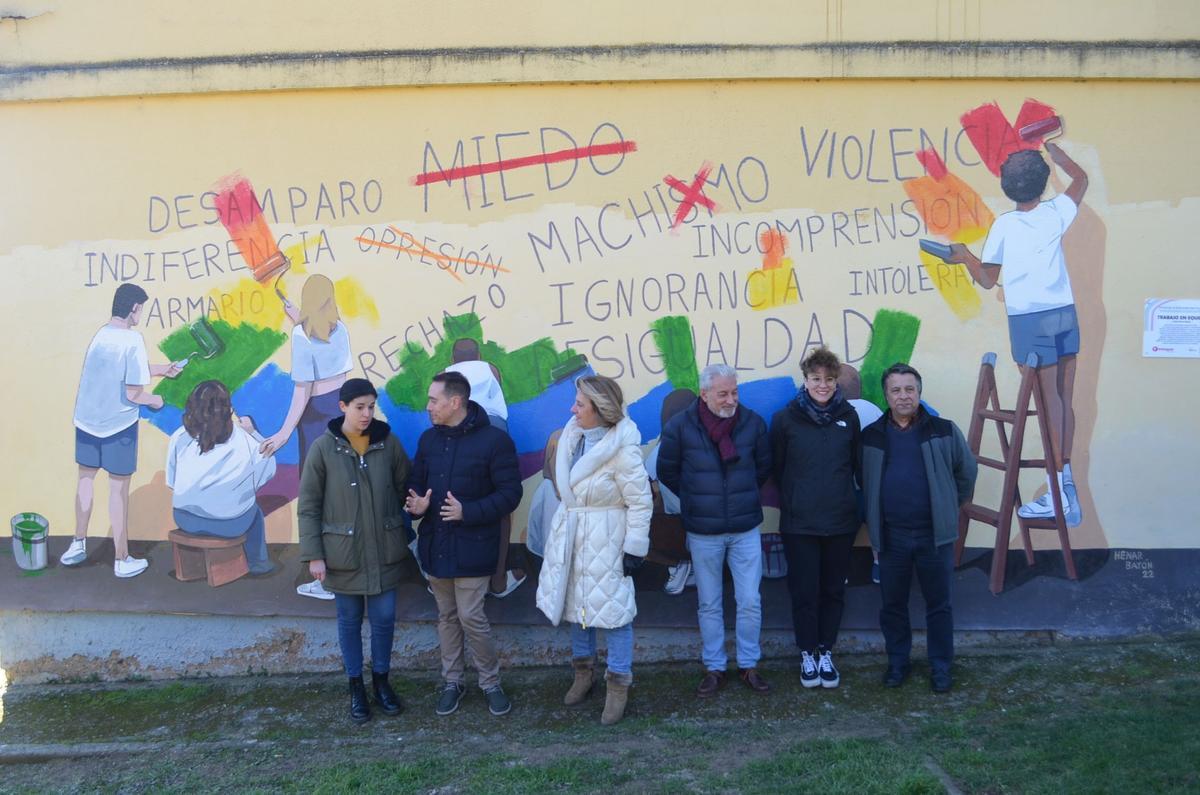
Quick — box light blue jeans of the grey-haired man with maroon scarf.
[688,527,762,671]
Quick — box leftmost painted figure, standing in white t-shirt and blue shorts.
[59,282,181,578]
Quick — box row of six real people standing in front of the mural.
[299,348,976,724]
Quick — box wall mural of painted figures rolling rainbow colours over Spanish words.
[5,89,1190,624]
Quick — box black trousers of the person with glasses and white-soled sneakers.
[784,533,856,654]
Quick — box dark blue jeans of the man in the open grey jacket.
[880,527,954,671]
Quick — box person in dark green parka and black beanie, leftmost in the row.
[298,378,409,723]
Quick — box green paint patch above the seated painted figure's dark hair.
[154,321,288,408]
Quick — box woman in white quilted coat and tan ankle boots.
[538,376,653,725]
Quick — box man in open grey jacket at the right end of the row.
[863,363,977,693]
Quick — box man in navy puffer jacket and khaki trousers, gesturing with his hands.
[404,372,521,715]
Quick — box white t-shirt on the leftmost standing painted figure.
[74,325,150,438]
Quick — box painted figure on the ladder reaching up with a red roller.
[946,116,1087,527]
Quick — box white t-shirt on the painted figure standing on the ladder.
[980,193,1079,315]
